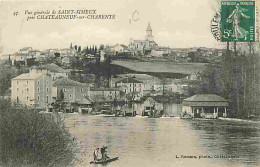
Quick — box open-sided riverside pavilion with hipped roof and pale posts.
[181,94,229,118]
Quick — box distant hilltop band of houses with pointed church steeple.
[1,23,224,66]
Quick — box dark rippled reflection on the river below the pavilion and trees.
[187,120,260,166]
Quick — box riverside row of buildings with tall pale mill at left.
[7,63,196,113]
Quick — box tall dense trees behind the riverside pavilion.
[189,43,260,117]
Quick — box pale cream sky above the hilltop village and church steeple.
[0,0,235,54]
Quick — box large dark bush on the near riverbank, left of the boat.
[0,100,77,167]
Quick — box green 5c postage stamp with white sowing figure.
[221,1,255,42]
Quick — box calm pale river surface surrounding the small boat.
[65,114,260,167]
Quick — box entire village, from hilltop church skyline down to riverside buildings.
[1,23,250,117]
